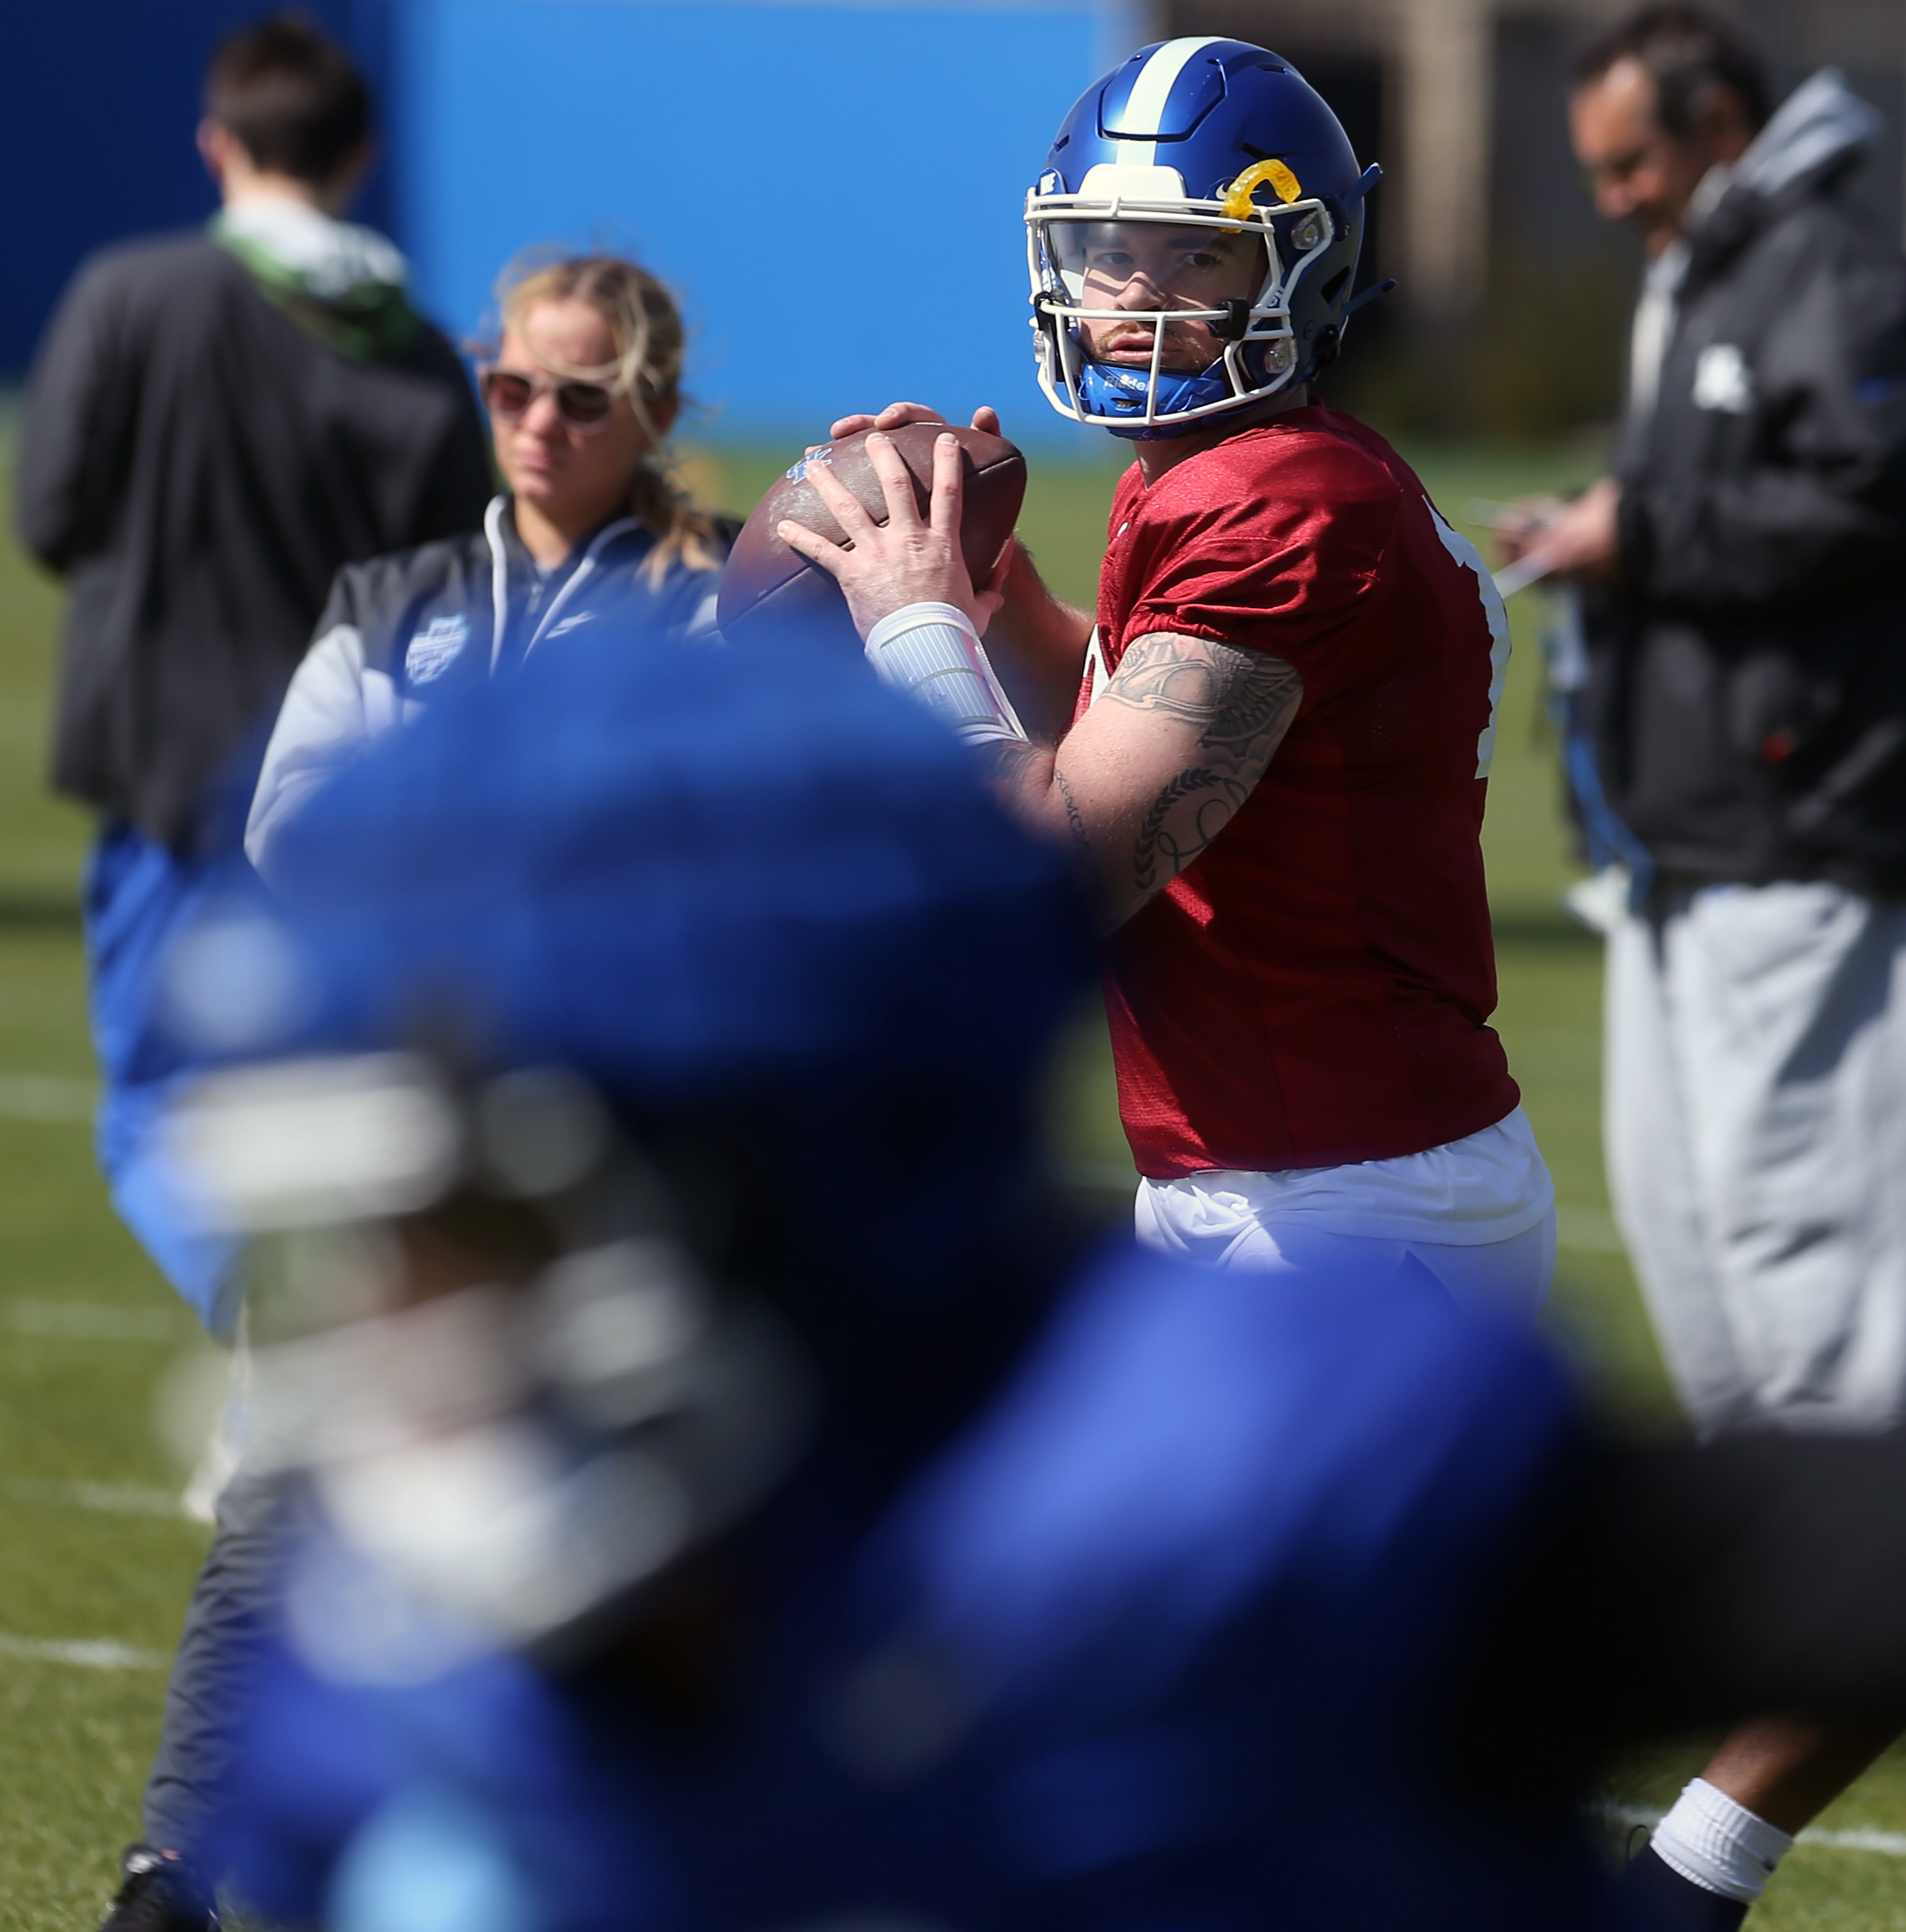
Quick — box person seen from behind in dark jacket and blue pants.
[17,15,489,1325]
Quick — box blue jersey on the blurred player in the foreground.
[208,1250,1605,1932]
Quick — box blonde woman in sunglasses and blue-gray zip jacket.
[245,255,735,877]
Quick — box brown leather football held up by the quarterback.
[715,423,1026,643]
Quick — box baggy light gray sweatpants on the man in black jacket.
[1603,885,1906,1434]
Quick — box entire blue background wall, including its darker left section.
[0,0,1144,440]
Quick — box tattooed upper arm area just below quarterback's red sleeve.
[1104,636,1303,893]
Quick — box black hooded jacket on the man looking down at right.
[1585,73,1906,895]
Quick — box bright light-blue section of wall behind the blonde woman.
[390,0,1129,439]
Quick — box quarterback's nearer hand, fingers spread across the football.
[775,437,1013,638]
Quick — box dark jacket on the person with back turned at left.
[15,236,491,846]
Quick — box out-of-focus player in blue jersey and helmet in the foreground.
[145,622,1906,1932]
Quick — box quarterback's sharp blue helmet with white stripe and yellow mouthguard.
[1026,39,1380,439]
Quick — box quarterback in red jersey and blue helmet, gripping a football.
[781,39,1554,1314]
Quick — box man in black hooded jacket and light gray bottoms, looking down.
[1508,6,1906,1926]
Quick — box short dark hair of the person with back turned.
[205,14,371,184]
